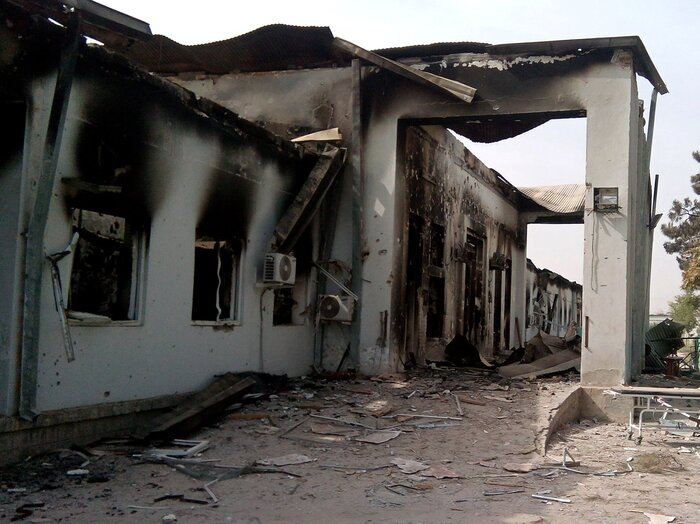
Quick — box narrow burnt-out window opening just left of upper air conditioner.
[192,236,242,322]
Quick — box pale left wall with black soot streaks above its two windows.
[10,50,315,411]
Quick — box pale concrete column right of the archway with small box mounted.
[581,53,644,386]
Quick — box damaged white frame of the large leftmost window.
[67,207,148,326]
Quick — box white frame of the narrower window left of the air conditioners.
[190,234,245,326]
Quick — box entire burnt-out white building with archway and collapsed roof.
[0,0,666,457]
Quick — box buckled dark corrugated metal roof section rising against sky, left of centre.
[119,24,348,74]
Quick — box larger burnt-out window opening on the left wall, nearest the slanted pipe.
[68,209,144,320]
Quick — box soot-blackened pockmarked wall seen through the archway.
[398,126,525,361]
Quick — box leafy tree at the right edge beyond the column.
[661,151,700,291]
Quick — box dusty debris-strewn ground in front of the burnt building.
[0,369,700,523]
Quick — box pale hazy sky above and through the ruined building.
[101,0,700,313]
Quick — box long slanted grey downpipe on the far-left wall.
[19,13,82,420]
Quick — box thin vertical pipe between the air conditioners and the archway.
[350,59,364,367]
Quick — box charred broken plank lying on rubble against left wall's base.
[134,373,255,439]
